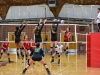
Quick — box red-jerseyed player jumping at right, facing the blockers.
[62,27,71,57]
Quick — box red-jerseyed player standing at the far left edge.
[0,38,11,63]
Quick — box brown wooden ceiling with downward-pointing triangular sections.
[0,0,100,19]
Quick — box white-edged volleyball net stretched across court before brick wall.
[0,24,91,48]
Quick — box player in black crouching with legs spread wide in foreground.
[22,43,51,75]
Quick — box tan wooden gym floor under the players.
[0,54,100,75]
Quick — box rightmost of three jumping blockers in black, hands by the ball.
[50,19,59,62]
